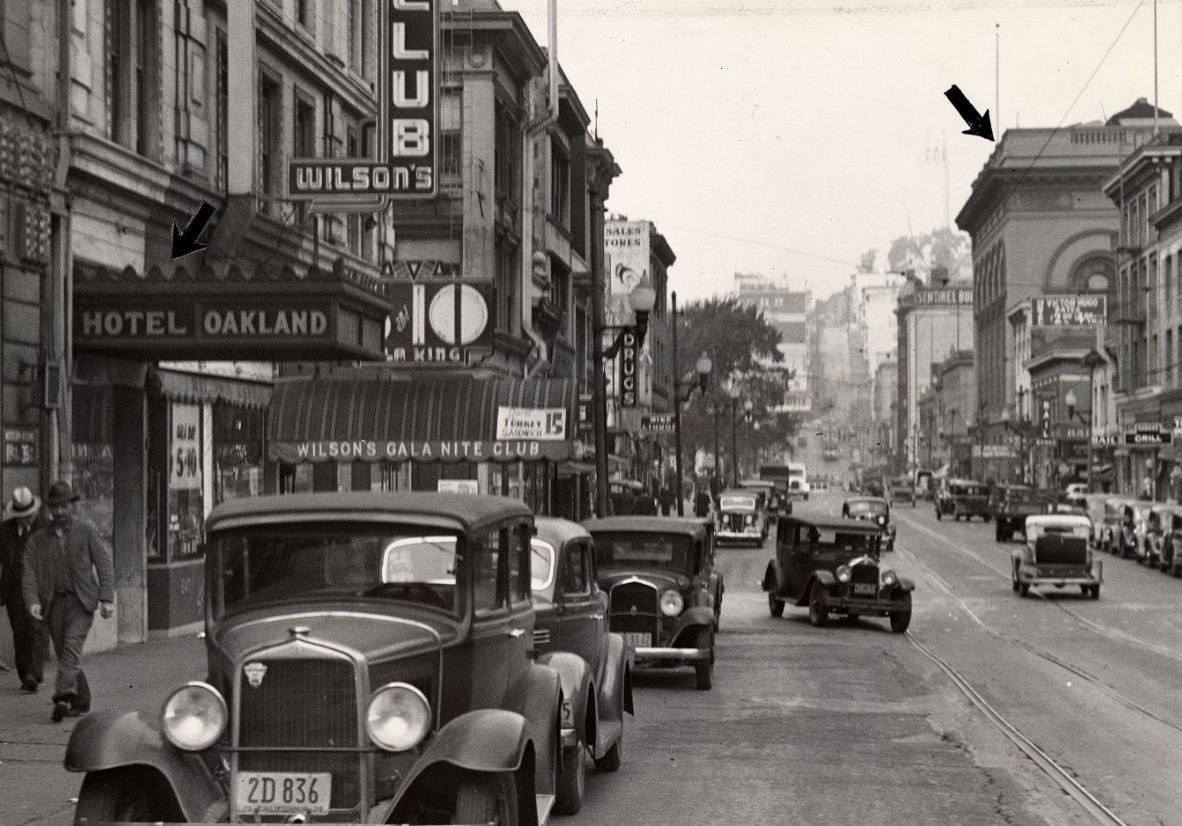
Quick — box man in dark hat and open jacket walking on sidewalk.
[22,481,115,723]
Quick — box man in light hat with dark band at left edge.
[0,488,50,694]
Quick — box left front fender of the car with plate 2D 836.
[65,710,227,822]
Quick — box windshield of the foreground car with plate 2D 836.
[206,523,462,617]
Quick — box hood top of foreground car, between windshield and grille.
[210,607,460,662]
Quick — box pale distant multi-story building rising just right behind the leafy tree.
[734,273,812,416]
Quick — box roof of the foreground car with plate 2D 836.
[206,490,533,531]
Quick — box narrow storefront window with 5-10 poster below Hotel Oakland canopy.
[168,403,204,560]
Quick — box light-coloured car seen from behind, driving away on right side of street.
[1011,514,1104,599]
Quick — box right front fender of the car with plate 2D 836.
[391,709,541,826]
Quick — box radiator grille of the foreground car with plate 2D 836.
[236,658,365,809]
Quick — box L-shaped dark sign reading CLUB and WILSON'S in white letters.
[287,0,442,213]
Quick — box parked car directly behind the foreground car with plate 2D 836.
[530,516,632,814]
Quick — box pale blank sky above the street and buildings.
[501,0,1182,301]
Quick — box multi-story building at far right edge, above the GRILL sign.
[1093,130,1182,500]
